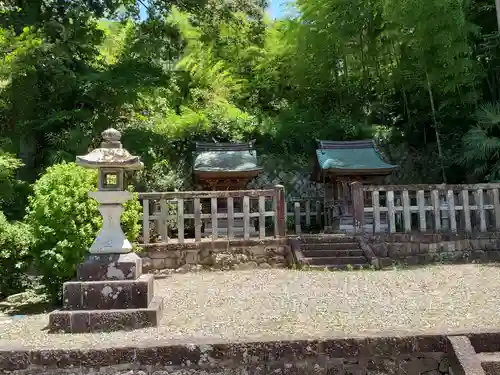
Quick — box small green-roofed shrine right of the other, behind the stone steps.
[313,140,398,231]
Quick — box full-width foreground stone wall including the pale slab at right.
[4,332,500,375]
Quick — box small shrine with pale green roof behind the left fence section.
[193,141,262,237]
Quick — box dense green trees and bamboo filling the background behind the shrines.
[0,0,500,210]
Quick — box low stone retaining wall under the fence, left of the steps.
[140,238,290,272]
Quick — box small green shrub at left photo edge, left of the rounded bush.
[0,212,33,299]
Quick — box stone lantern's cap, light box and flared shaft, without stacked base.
[76,128,143,254]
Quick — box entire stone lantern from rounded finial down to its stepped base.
[49,129,163,333]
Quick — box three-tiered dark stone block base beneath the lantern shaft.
[49,253,163,333]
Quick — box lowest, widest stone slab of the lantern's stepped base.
[48,297,163,333]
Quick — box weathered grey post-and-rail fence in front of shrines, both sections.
[139,183,500,239]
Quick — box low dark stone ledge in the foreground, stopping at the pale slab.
[0,335,449,374]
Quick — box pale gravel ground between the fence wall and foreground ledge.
[0,265,500,348]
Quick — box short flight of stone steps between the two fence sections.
[291,234,371,270]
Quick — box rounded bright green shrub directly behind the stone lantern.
[26,163,141,301]
